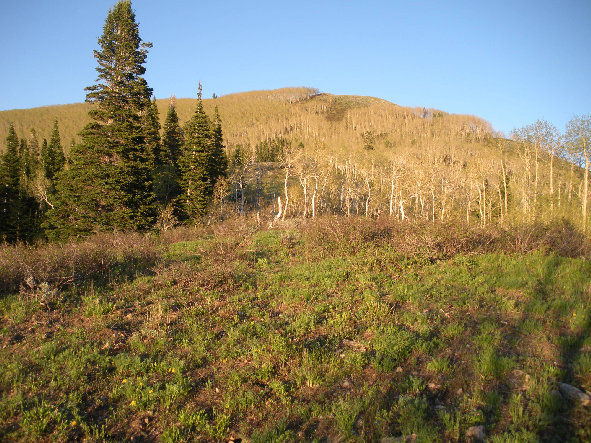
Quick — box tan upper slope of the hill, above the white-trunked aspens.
[0,88,490,156]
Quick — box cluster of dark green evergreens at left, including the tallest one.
[0,0,227,242]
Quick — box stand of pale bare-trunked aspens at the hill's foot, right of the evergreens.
[223,116,591,229]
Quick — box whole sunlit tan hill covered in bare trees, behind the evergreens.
[0,88,583,231]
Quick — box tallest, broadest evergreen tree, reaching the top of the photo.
[49,0,156,237]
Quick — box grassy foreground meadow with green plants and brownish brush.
[0,217,591,442]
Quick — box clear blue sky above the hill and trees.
[0,0,591,133]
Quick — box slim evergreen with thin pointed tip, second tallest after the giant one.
[180,84,213,219]
